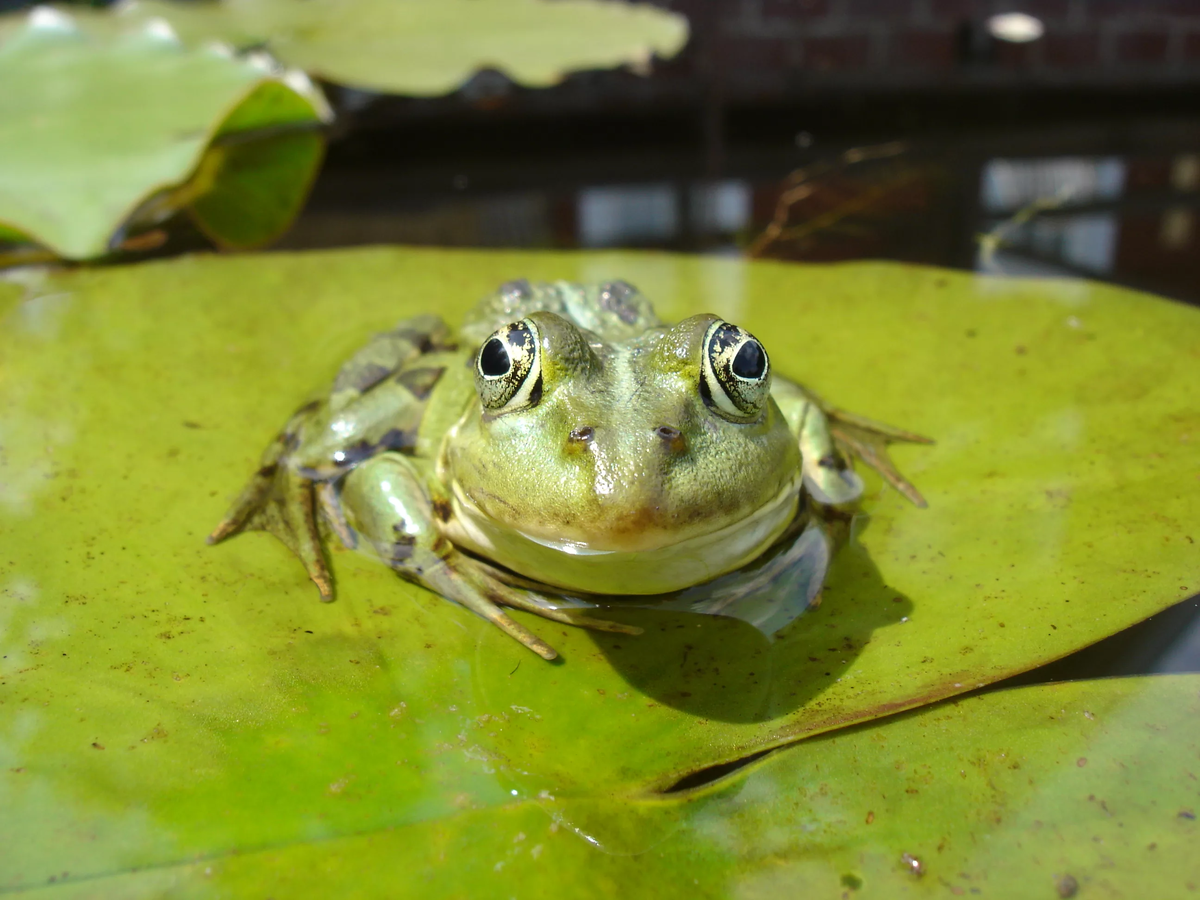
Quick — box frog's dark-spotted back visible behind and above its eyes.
[461,278,664,344]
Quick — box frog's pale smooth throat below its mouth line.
[445,476,800,594]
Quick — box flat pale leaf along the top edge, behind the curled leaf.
[122,0,688,95]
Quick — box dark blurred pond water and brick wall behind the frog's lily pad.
[278,0,1200,301]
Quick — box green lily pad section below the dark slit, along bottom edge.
[28,676,1200,900]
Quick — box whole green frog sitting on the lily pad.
[209,281,925,659]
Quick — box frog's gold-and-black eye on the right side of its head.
[700,322,770,421]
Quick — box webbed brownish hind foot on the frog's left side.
[208,409,338,602]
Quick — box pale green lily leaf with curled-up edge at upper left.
[0,8,324,259]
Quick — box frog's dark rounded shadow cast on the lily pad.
[578,520,912,722]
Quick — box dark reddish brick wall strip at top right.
[659,0,1200,88]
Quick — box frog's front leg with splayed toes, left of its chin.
[341,452,641,659]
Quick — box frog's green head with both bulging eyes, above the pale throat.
[444,312,799,551]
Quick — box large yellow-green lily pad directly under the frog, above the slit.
[0,250,1200,889]
